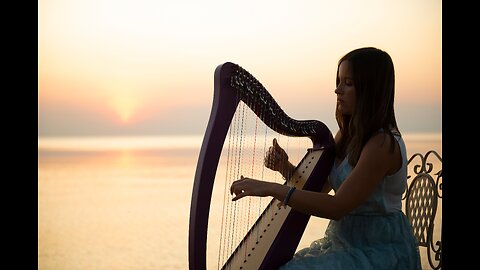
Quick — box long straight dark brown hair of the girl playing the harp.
[335,47,400,166]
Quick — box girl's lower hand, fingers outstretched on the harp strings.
[230,175,276,201]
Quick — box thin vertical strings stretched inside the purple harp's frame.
[211,97,311,269]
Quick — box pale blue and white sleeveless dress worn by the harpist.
[279,136,421,270]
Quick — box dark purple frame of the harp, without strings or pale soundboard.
[188,62,334,270]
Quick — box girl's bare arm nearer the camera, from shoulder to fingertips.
[230,133,401,220]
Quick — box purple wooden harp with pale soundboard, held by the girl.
[188,62,334,270]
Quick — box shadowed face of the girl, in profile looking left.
[335,61,356,115]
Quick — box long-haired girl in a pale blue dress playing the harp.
[230,47,421,270]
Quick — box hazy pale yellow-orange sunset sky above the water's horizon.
[38,0,442,136]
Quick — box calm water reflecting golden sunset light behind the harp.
[38,134,442,270]
